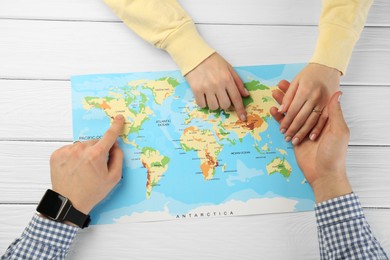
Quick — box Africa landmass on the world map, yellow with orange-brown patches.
[180,126,223,180]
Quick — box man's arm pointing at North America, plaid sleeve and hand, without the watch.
[1,116,124,260]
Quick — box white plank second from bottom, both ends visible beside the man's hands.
[0,142,390,208]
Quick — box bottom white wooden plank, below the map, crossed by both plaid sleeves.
[0,205,390,260]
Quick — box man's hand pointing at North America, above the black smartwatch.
[50,115,124,214]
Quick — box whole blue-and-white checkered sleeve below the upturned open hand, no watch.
[315,193,388,259]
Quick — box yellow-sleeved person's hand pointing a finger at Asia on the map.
[185,53,249,121]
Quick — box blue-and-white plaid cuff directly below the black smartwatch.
[22,215,79,251]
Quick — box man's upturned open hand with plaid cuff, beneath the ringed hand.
[270,81,352,203]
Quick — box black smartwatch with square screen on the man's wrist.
[37,189,91,228]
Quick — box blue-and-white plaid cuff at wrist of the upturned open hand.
[314,193,364,227]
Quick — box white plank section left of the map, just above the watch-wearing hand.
[0,80,72,141]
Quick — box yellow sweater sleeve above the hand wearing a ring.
[310,0,372,74]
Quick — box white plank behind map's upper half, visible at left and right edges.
[0,80,390,145]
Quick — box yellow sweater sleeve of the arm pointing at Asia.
[104,0,215,75]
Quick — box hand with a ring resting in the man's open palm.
[279,63,341,145]
